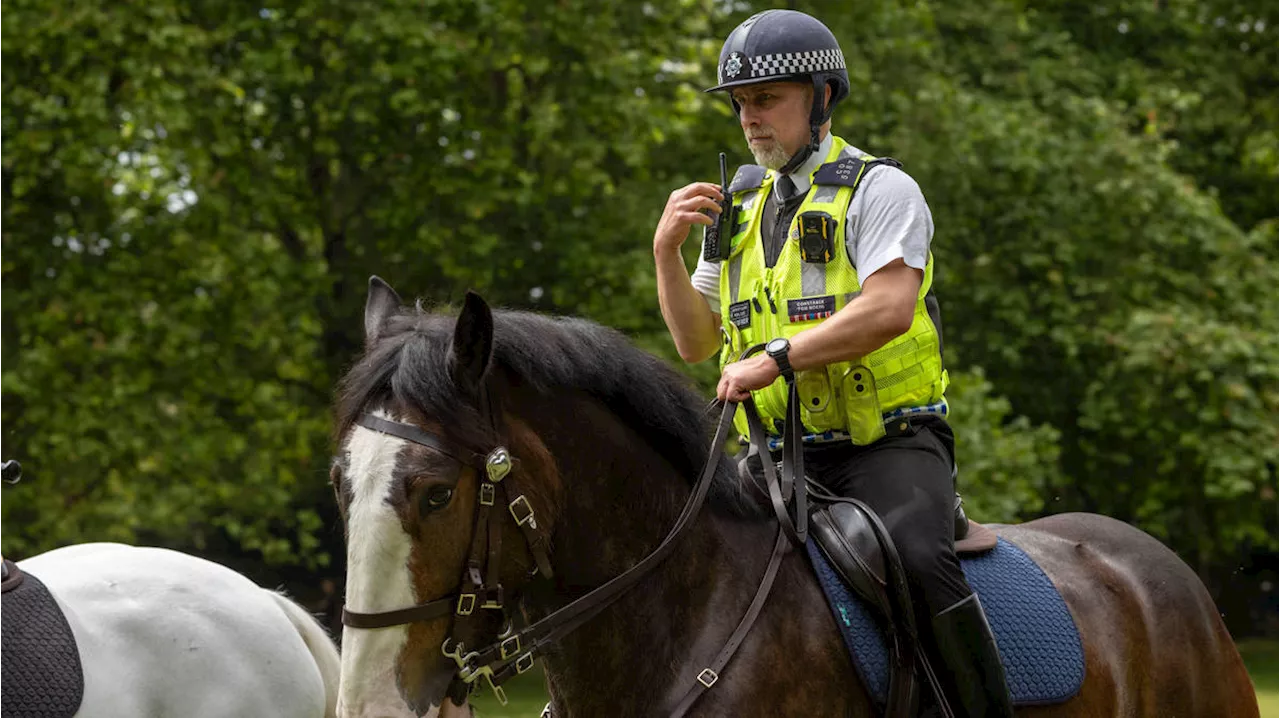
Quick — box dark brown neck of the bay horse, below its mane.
[517,394,772,715]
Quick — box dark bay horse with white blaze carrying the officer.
[332,278,1258,718]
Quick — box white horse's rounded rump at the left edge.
[0,544,340,718]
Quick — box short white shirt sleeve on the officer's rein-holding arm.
[845,165,933,282]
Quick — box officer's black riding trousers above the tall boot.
[773,416,973,619]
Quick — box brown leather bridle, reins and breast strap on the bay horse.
[342,344,805,718]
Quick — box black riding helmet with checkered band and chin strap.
[707,10,849,174]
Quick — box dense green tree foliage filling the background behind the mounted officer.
[0,0,1280,588]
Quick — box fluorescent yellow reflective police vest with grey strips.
[719,137,947,444]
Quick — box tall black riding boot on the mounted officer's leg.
[932,594,1014,718]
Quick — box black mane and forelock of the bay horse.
[337,305,762,516]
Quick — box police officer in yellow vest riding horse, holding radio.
[654,10,1012,717]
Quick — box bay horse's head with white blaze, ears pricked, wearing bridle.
[332,278,554,718]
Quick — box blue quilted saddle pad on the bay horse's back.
[805,539,1084,705]
